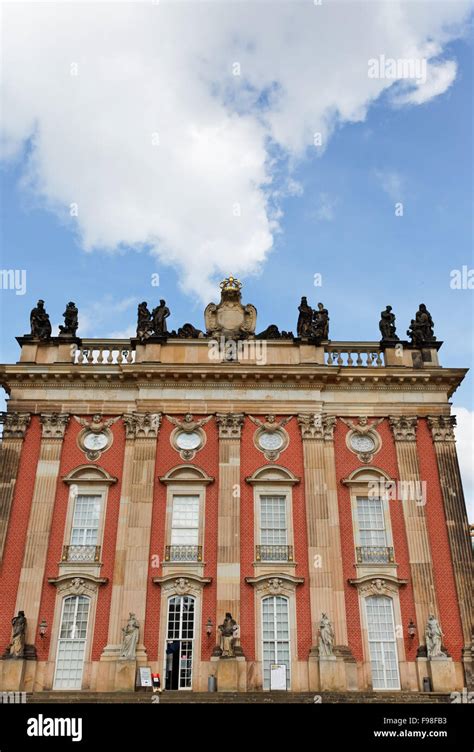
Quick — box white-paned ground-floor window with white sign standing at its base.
[262,595,290,689]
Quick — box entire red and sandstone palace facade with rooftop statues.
[0,278,472,692]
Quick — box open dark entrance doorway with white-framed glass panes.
[165,595,195,689]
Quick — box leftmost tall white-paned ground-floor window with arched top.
[54,595,89,689]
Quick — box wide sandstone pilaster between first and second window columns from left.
[98,413,161,664]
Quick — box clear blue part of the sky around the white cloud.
[0,0,473,516]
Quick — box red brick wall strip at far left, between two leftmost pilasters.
[0,415,41,654]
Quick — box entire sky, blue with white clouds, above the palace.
[0,0,474,517]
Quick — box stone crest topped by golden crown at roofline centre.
[204,277,257,339]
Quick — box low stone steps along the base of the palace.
[27,690,450,705]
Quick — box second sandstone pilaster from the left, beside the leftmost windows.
[15,413,69,644]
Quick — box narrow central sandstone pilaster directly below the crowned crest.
[216,413,244,640]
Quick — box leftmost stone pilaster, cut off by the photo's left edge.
[0,413,31,563]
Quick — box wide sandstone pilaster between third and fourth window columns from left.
[298,414,347,647]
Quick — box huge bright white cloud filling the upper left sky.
[2,0,472,301]
